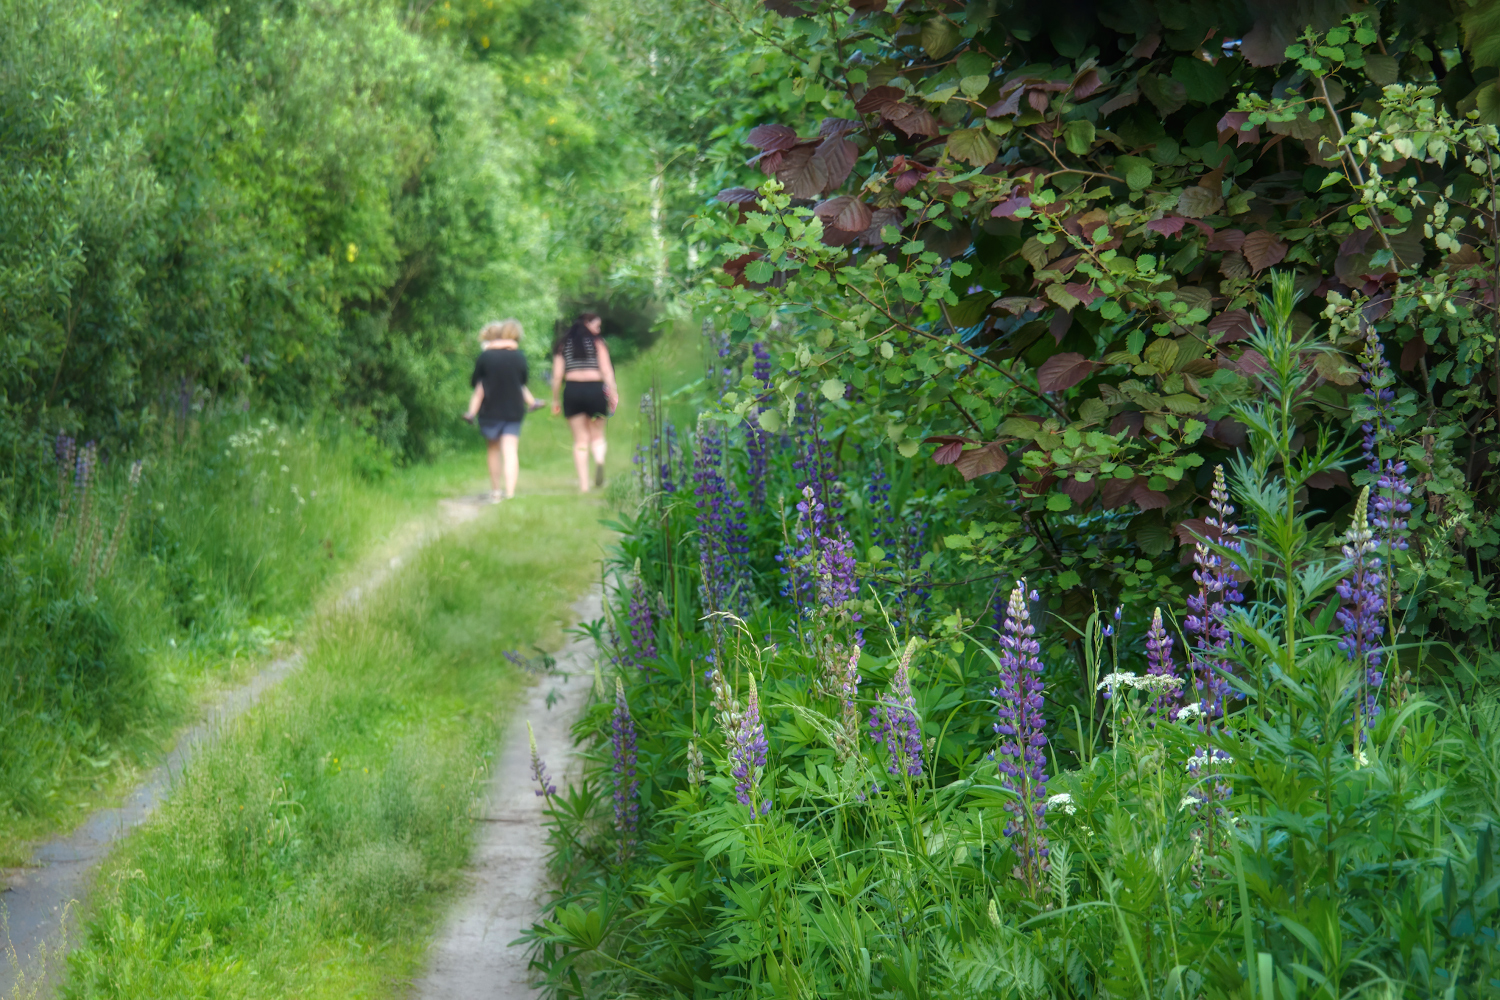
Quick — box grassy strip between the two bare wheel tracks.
[63,494,603,999]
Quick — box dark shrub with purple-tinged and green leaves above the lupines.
[687,1,1500,688]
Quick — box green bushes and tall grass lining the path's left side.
[0,0,708,862]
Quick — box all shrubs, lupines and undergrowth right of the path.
[530,1,1500,999]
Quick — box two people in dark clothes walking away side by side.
[464,312,620,502]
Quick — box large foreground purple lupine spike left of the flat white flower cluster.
[990,580,1050,895]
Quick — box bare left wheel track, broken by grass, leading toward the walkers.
[0,498,486,1000]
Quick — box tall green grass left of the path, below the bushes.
[0,412,444,864]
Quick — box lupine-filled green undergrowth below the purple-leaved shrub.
[530,281,1500,999]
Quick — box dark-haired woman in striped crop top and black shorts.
[552,312,620,493]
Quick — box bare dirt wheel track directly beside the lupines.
[411,586,603,1000]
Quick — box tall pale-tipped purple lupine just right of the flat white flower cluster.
[1184,465,1244,729]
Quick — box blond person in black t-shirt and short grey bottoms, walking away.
[464,319,542,504]
